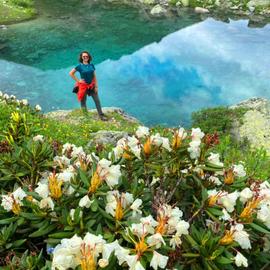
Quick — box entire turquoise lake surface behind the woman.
[0,0,270,126]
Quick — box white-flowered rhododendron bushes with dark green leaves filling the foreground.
[0,92,270,270]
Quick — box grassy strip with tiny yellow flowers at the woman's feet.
[0,103,138,149]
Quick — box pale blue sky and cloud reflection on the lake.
[0,19,270,126]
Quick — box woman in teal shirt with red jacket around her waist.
[69,51,106,121]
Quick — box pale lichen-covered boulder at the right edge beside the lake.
[230,98,270,155]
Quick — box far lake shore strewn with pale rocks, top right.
[107,0,270,27]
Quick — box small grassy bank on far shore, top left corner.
[0,0,36,24]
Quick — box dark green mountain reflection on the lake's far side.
[0,0,199,70]
